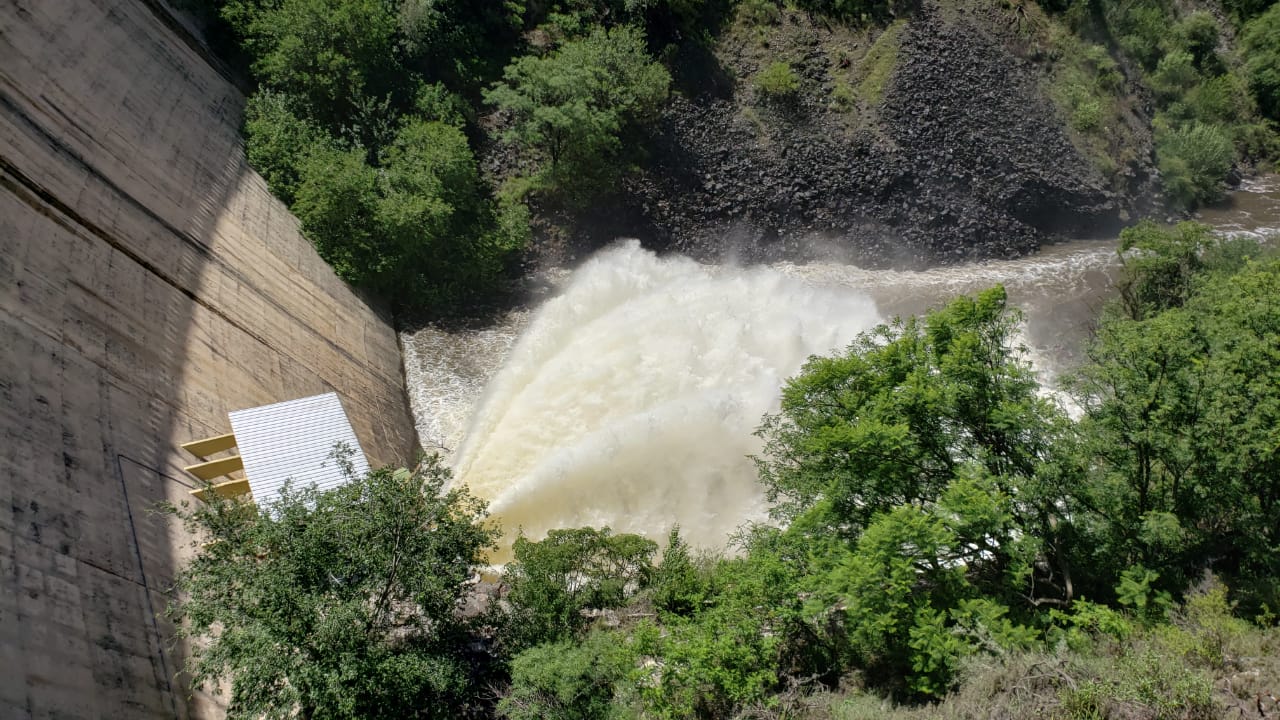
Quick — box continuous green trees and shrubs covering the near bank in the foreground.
[175,224,1280,719]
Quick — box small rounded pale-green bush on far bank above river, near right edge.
[1156,122,1235,208]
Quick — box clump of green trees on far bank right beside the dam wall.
[223,0,530,313]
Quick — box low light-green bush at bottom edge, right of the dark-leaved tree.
[498,632,636,720]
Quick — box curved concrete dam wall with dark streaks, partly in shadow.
[0,0,416,719]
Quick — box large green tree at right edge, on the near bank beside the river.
[1071,224,1280,597]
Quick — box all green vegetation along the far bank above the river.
[194,0,1280,313]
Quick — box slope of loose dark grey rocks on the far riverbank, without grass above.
[627,4,1123,266]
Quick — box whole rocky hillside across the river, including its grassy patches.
[555,0,1151,265]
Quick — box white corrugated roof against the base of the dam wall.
[228,392,369,507]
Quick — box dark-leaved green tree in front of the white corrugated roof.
[161,457,497,720]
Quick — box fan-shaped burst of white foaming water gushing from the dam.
[454,241,882,556]
